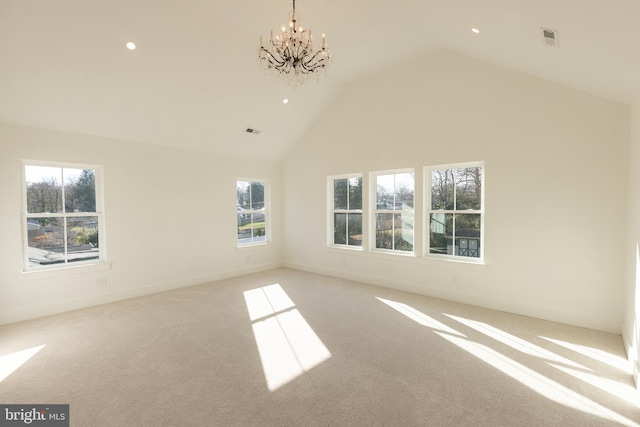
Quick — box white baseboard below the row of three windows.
[284,261,622,334]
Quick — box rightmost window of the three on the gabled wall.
[425,163,484,260]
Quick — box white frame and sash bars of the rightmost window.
[423,161,486,264]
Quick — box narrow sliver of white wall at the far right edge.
[622,101,640,389]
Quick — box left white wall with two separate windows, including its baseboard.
[0,124,282,323]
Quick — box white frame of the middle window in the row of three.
[369,168,416,256]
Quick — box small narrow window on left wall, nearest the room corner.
[236,180,269,246]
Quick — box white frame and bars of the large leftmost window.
[20,160,107,273]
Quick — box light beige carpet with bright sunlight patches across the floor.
[0,269,640,427]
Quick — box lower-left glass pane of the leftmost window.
[26,218,65,267]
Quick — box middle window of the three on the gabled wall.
[372,170,414,253]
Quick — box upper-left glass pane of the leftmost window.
[25,166,62,213]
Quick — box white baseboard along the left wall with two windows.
[0,263,282,325]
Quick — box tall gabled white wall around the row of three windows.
[283,51,629,333]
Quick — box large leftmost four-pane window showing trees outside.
[23,162,104,270]
